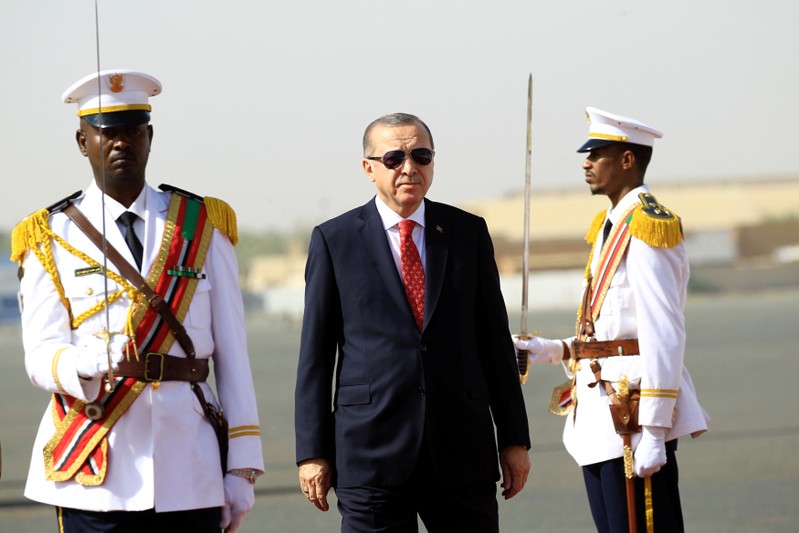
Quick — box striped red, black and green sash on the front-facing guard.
[44,193,214,485]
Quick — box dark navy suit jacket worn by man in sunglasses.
[295,199,530,487]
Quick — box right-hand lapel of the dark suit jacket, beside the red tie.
[422,199,449,329]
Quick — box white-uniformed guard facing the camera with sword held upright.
[12,70,263,533]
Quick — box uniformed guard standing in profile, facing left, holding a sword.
[514,107,708,532]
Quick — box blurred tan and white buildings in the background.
[244,176,799,318]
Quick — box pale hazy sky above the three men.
[0,0,799,229]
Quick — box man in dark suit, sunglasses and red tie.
[295,113,530,533]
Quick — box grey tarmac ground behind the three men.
[0,288,799,533]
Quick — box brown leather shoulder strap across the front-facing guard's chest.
[63,202,196,358]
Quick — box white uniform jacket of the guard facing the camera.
[20,181,263,512]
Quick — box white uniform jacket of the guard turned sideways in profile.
[563,186,709,466]
